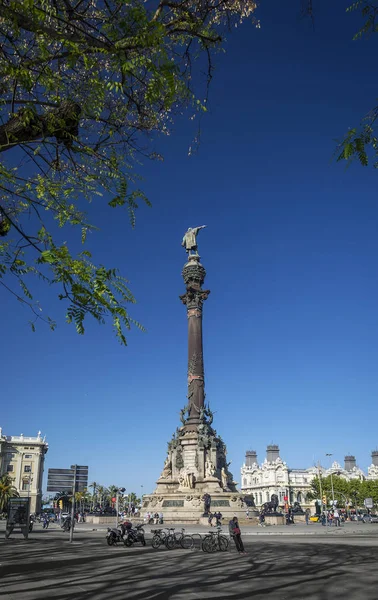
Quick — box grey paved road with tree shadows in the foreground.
[0,524,378,600]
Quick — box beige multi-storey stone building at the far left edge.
[0,427,48,512]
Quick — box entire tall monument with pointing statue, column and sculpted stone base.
[142,225,245,523]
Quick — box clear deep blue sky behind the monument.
[0,0,378,493]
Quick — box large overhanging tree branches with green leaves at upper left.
[0,0,256,344]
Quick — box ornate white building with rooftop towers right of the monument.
[241,444,378,510]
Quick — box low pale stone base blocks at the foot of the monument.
[142,494,250,524]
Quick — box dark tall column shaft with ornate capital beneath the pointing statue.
[180,254,210,431]
